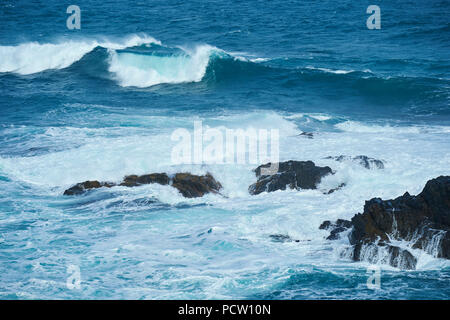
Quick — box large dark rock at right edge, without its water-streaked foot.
[350,176,450,259]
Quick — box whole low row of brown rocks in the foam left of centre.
[64,173,222,198]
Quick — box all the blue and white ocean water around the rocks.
[0,0,450,299]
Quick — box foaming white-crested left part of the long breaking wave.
[0,37,272,88]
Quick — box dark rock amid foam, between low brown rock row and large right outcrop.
[248,160,332,195]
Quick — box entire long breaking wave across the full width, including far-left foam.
[0,36,450,114]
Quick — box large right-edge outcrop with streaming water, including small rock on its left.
[321,176,450,269]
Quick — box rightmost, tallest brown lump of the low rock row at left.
[172,173,222,198]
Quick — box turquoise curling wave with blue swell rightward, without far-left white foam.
[79,45,450,113]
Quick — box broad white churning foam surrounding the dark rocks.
[0,111,450,276]
